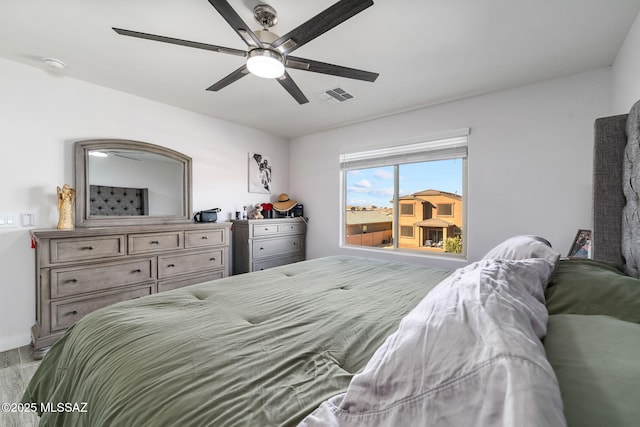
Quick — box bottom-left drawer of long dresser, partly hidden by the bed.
[51,283,154,331]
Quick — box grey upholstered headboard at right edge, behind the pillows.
[592,101,640,277]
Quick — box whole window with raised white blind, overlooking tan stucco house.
[340,129,469,253]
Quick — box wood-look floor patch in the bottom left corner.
[0,346,39,427]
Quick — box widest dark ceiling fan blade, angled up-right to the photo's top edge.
[272,0,373,55]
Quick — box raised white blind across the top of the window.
[340,129,469,170]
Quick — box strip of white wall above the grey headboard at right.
[613,15,640,114]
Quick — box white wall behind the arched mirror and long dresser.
[0,59,289,351]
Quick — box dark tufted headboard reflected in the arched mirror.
[89,185,149,216]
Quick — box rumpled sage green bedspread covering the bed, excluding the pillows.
[23,257,450,427]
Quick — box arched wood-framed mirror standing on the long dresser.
[75,139,192,227]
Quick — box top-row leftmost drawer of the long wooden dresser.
[49,234,125,263]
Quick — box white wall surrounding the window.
[290,68,611,268]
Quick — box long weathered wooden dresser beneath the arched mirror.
[31,223,231,358]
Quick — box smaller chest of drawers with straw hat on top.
[232,217,306,274]
